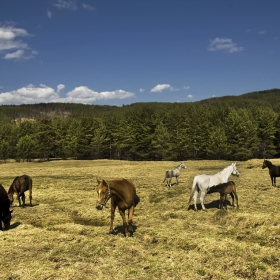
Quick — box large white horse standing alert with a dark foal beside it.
[189,163,240,211]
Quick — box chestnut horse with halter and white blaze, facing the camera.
[96,178,140,236]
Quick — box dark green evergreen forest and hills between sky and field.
[0,89,280,161]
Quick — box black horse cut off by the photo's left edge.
[0,184,13,230]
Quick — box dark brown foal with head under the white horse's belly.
[207,181,239,209]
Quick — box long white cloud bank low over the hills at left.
[0,84,135,105]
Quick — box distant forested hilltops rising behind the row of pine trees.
[0,89,280,120]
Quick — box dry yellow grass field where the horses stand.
[0,160,280,280]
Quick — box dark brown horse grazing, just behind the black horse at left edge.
[8,175,32,206]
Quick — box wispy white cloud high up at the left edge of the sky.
[0,25,37,60]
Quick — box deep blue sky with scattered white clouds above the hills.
[0,0,280,106]
